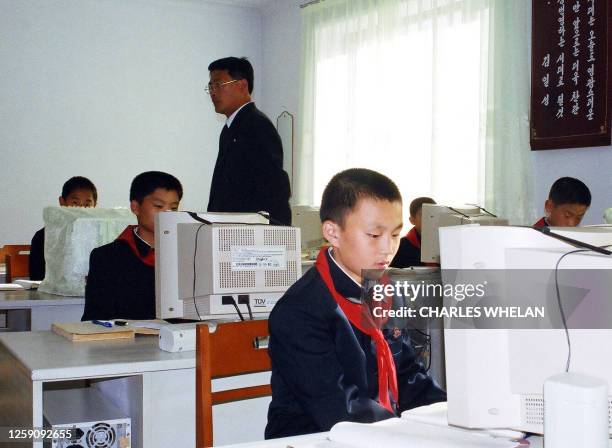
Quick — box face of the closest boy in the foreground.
[323,198,402,282]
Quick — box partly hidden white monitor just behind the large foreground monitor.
[421,204,508,263]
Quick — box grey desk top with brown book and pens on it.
[0,331,195,380]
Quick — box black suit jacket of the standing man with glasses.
[208,103,291,225]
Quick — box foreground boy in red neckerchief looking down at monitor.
[265,169,446,439]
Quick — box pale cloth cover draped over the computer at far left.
[38,207,136,296]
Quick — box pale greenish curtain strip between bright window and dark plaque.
[485,0,537,225]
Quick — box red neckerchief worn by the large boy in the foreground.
[315,248,397,413]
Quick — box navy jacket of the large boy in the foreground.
[265,250,446,439]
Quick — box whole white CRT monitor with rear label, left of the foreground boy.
[155,212,301,320]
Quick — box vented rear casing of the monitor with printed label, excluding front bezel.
[178,223,301,320]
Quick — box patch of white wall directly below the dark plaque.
[533,146,612,224]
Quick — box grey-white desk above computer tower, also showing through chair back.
[0,331,270,448]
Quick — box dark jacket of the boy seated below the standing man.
[81,234,155,320]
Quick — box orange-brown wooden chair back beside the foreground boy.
[196,320,272,448]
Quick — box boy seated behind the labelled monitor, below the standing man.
[81,171,183,320]
